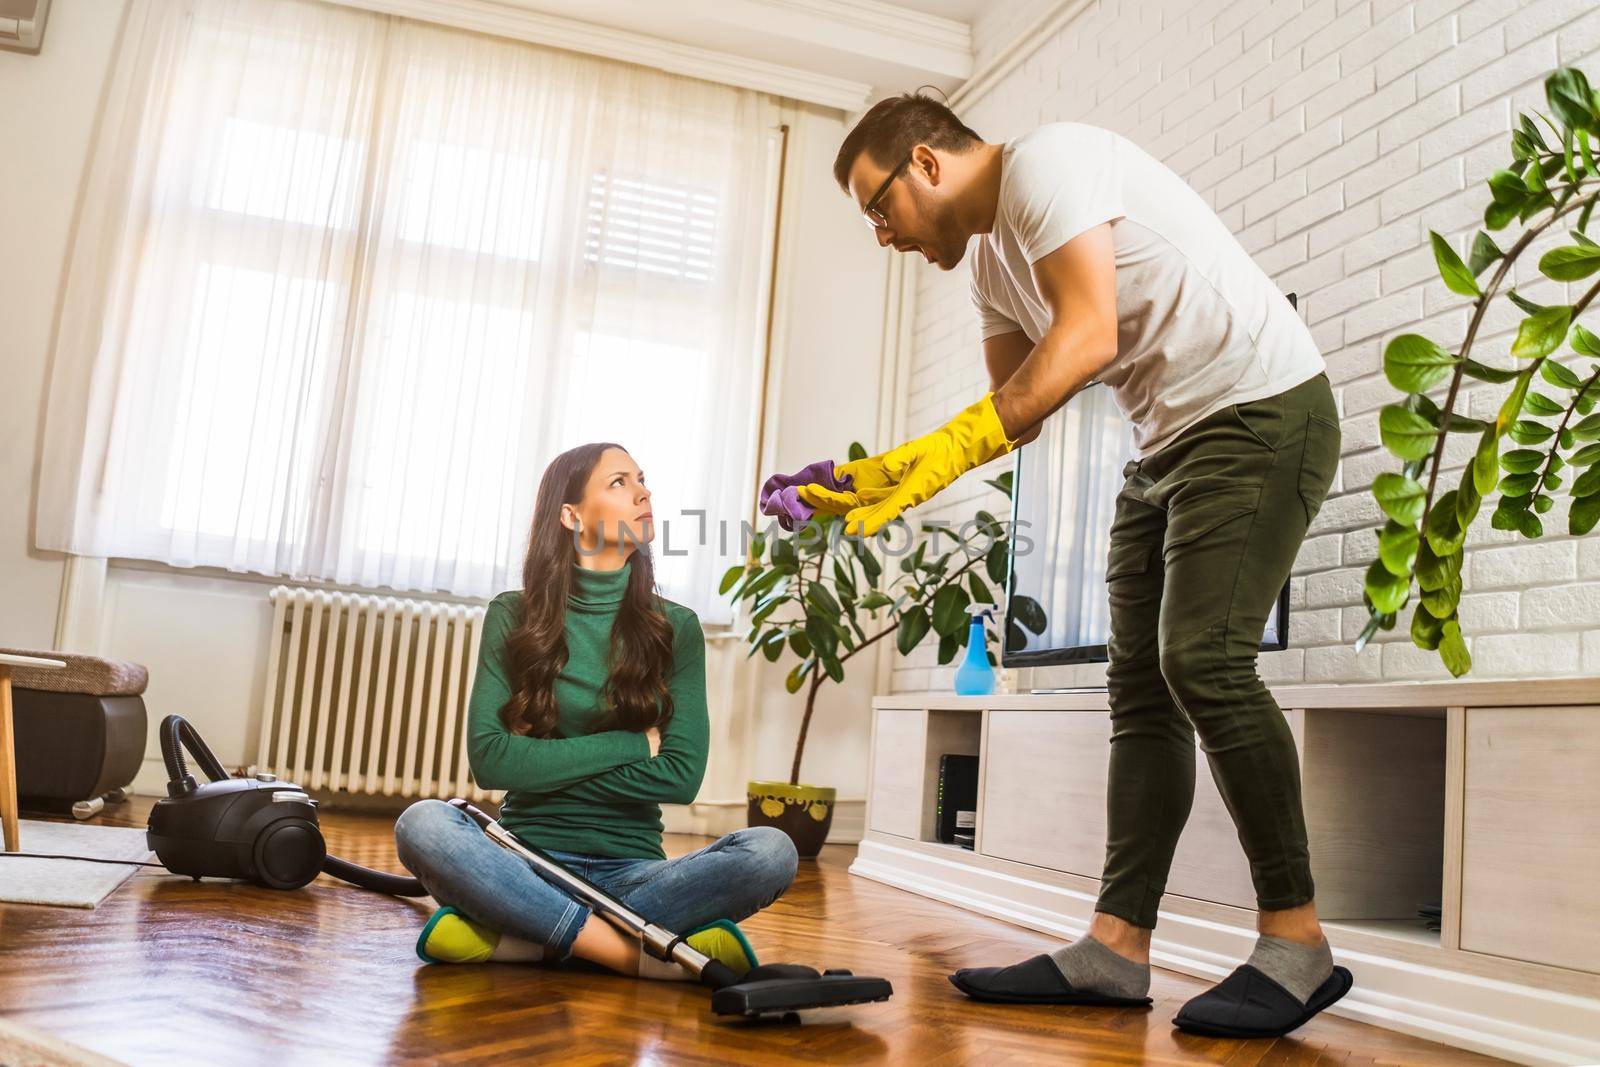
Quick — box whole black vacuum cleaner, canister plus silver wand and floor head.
[146,715,894,1019]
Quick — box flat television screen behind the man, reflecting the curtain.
[1002,386,1288,667]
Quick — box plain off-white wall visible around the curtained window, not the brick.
[0,0,886,833]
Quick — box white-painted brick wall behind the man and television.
[894,0,1600,689]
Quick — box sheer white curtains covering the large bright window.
[37,0,778,622]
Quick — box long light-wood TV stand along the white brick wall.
[851,678,1600,1064]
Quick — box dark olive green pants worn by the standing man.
[1096,374,1339,928]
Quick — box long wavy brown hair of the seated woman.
[501,442,672,737]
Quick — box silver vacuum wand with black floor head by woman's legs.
[450,797,894,1017]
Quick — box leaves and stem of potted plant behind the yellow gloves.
[722,443,1045,785]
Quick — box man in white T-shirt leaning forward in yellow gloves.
[762,94,1350,1037]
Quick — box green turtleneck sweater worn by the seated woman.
[467,565,710,859]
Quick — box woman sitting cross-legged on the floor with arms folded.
[395,443,797,979]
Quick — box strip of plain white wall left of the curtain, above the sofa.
[0,0,123,648]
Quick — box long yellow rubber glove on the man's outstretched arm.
[798,392,1016,537]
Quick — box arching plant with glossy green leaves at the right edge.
[1357,67,1600,677]
